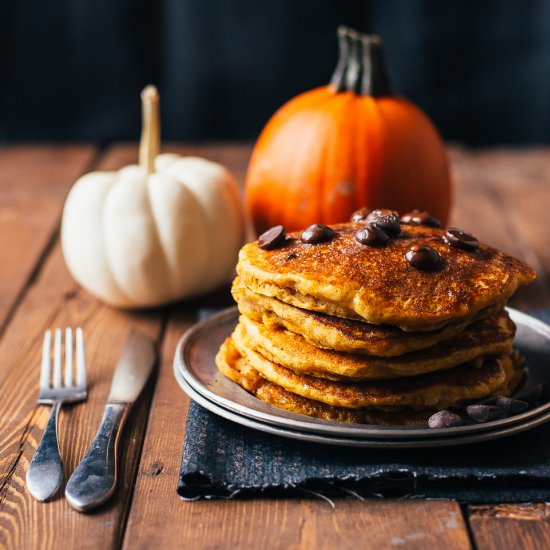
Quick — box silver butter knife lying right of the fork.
[65,330,156,512]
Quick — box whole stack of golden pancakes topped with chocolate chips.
[216,209,535,424]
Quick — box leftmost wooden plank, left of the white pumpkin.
[0,145,96,334]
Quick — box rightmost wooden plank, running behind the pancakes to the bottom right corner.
[453,149,550,550]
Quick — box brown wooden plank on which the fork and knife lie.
[0,144,165,548]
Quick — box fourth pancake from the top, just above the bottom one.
[233,340,523,410]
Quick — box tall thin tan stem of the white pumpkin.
[139,84,160,174]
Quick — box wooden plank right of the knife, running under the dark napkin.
[124,146,470,549]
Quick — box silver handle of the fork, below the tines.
[27,401,63,502]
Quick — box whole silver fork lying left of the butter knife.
[27,328,87,502]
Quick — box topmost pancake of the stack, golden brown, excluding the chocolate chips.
[237,223,535,331]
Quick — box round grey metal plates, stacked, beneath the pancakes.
[174,307,550,446]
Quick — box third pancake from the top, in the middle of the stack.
[236,311,515,381]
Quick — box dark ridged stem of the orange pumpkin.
[330,26,392,97]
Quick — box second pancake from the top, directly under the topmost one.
[235,284,502,357]
